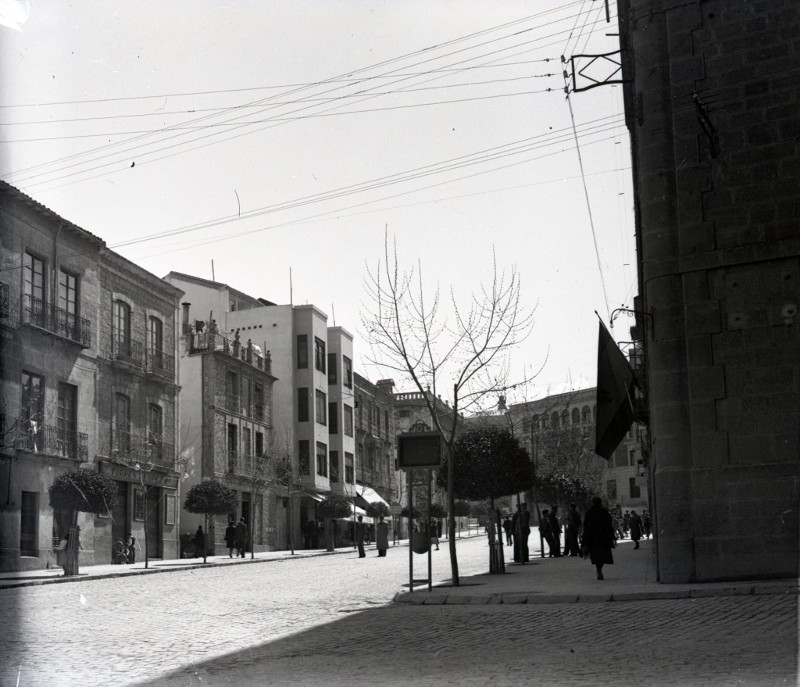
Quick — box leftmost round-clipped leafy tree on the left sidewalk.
[49,470,117,575]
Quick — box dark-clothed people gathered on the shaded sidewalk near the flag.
[503,497,652,580]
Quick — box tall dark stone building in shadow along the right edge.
[618,0,800,582]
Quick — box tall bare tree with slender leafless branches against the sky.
[362,233,533,586]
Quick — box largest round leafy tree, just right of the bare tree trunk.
[436,427,533,572]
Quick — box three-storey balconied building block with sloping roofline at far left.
[0,183,180,570]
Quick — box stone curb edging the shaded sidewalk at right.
[392,584,800,606]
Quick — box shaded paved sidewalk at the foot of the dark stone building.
[394,540,798,605]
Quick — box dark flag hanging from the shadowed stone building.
[594,321,635,459]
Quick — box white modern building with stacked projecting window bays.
[165,272,356,548]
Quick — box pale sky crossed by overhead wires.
[0,0,636,402]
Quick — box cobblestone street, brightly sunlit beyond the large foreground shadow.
[0,538,797,687]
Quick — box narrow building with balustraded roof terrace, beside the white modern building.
[179,304,276,551]
